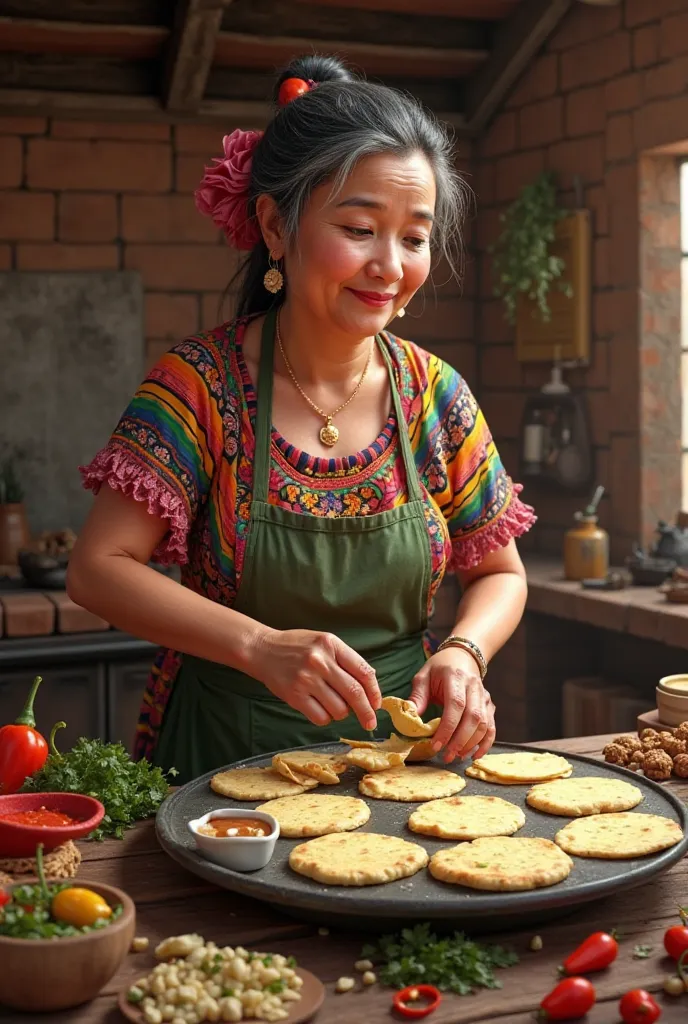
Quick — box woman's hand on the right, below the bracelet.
[410,647,495,763]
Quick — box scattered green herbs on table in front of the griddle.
[361,924,518,995]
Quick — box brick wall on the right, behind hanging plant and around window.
[475,0,688,560]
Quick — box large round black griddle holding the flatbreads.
[156,743,688,931]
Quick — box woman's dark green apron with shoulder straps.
[154,312,431,784]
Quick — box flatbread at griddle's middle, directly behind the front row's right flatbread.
[409,797,525,840]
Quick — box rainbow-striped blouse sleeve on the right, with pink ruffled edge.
[415,355,535,569]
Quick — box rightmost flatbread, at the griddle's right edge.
[554,811,683,860]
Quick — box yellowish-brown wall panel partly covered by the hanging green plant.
[516,210,592,364]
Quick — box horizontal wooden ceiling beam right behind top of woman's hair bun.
[215,32,488,78]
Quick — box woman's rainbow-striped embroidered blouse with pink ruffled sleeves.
[81,321,535,757]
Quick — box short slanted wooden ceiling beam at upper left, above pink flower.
[163,0,231,111]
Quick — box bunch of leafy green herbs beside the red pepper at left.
[23,737,173,840]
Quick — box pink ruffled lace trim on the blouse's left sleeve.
[79,444,188,565]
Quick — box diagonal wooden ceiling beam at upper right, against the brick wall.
[465,0,573,133]
